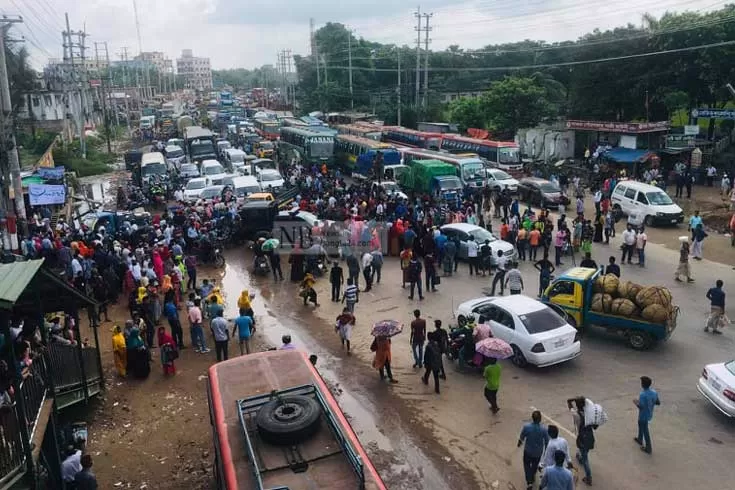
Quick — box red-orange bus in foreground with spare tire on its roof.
[207,350,386,490]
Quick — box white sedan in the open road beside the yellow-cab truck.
[456,294,582,367]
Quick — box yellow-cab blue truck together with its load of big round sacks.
[542,267,679,350]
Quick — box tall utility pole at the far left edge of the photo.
[0,16,28,251]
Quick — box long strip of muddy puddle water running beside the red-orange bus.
[217,253,458,490]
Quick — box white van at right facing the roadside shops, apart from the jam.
[611,180,684,226]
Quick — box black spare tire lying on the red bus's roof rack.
[255,395,321,446]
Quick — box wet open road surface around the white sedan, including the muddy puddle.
[217,233,735,489]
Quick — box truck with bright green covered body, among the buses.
[400,160,462,201]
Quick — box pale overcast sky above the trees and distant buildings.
[0,0,728,68]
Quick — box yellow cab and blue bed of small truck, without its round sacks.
[541,267,679,350]
